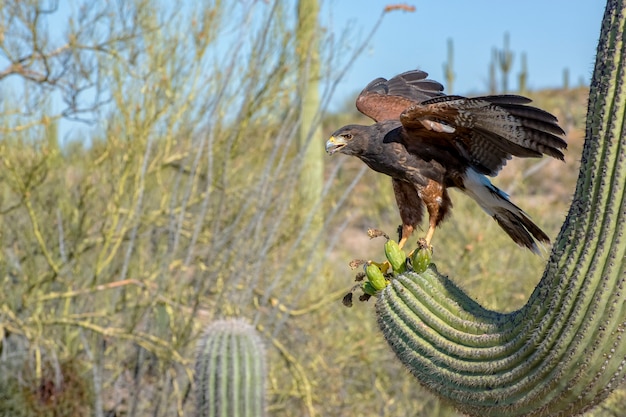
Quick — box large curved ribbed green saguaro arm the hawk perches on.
[376,0,626,416]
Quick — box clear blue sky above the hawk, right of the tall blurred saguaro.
[322,0,605,105]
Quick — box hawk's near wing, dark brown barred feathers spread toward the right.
[400,95,567,175]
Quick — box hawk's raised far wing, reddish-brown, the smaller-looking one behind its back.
[356,70,443,122]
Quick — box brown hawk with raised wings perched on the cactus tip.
[326,70,567,253]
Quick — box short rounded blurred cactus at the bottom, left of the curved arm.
[195,319,267,417]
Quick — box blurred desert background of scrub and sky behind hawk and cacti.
[0,0,626,417]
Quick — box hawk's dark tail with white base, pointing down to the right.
[463,168,550,254]
